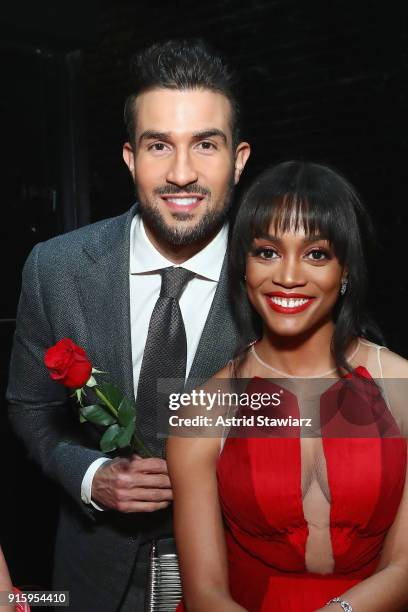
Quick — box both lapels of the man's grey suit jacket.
[77,206,250,404]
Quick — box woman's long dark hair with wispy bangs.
[230,161,383,371]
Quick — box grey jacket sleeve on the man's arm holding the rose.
[7,244,104,519]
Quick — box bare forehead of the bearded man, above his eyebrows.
[135,88,231,134]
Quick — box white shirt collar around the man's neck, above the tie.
[130,215,228,281]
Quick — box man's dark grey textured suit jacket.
[7,206,252,612]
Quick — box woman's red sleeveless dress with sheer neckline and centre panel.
[180,339,408,612]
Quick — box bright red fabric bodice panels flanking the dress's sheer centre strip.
[217,368,406,575]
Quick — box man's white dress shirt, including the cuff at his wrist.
[81,215,228,510]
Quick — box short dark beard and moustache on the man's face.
[136,175,234,246]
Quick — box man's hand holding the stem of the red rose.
[92,455,173,512]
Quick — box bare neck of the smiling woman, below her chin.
[256,321,342,377]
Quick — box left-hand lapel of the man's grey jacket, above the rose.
[77,207,136,397]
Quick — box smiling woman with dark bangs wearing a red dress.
[168,162,408,612]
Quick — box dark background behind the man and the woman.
[0,0,408,588]
